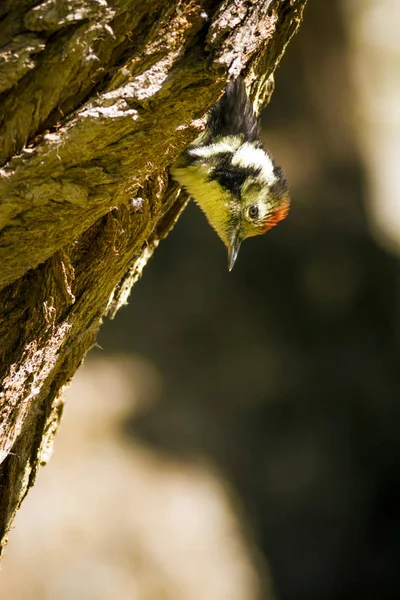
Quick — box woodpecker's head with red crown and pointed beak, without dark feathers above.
[171,135,290,271]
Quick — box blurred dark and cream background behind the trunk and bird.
[0,0,400,600]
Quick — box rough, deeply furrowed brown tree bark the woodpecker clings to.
[0,0,306,548]
